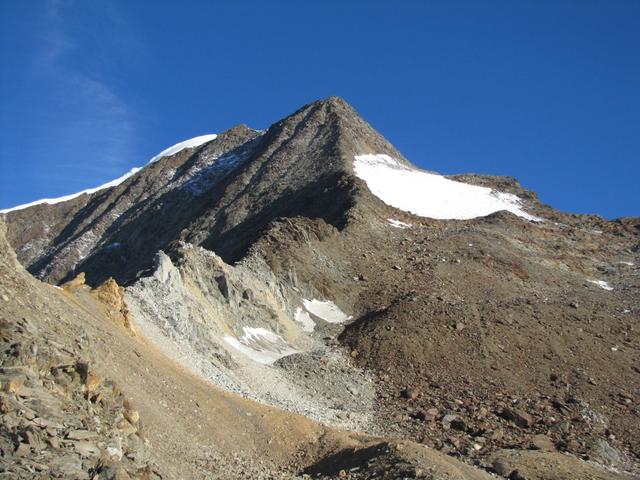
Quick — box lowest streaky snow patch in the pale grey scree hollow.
[224,327,298,365]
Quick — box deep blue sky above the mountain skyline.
[0,0,640,218]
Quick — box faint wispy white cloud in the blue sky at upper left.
[32,0,141,184]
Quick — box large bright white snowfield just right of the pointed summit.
[353,154,540,221]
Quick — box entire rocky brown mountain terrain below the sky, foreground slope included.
[0,97,640,480]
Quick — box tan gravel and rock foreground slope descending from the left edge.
[0,216,504,480]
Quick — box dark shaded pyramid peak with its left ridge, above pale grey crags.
[7,98,401,283]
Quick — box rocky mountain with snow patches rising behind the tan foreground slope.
[5,98,640,478]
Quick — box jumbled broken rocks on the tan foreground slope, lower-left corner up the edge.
[0,218,161,479]
